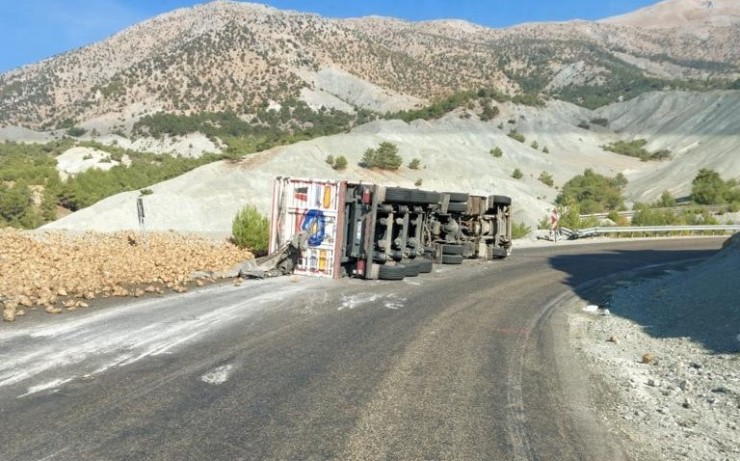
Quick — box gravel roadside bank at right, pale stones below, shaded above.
[569,234,740,461]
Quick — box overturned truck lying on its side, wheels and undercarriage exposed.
[270,177,511,280]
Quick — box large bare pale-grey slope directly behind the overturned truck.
[45,92,740,236]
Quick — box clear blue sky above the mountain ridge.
[0,0,658,72]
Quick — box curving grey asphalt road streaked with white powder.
[0,239,721,461]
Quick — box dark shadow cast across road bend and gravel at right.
[550,249,738,353]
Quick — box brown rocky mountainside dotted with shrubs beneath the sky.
[0,0,740,134]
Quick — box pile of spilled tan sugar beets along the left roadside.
[0,229,252,321]
